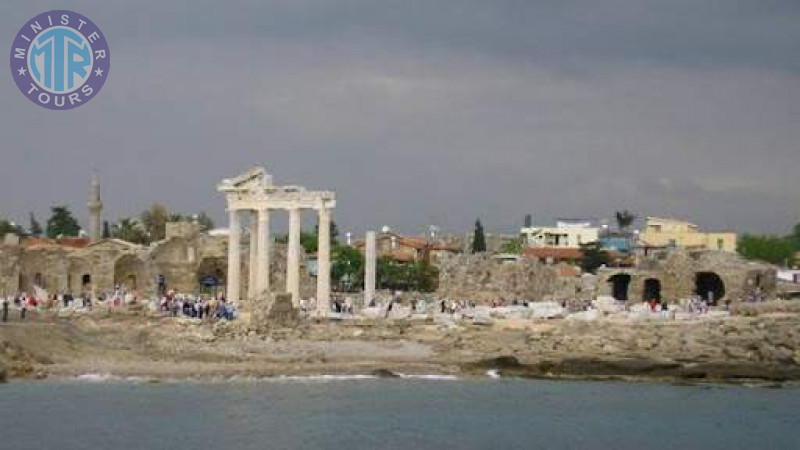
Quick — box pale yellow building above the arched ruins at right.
[639,217,736,253]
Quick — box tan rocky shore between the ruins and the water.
[0,310,800,382]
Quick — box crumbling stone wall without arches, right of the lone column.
[437,254,564,303]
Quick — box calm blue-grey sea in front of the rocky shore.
[0,376,800,450]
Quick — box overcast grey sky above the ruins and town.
[0,0,800,237]
